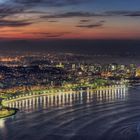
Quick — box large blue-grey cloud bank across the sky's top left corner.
[0,0,92,18]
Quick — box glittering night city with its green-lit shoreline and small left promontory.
[0,53,140,120]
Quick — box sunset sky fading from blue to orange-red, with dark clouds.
[0,0,140,40]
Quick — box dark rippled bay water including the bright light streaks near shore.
[0,87,140,140]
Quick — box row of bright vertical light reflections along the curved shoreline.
[8,86,127,110]
